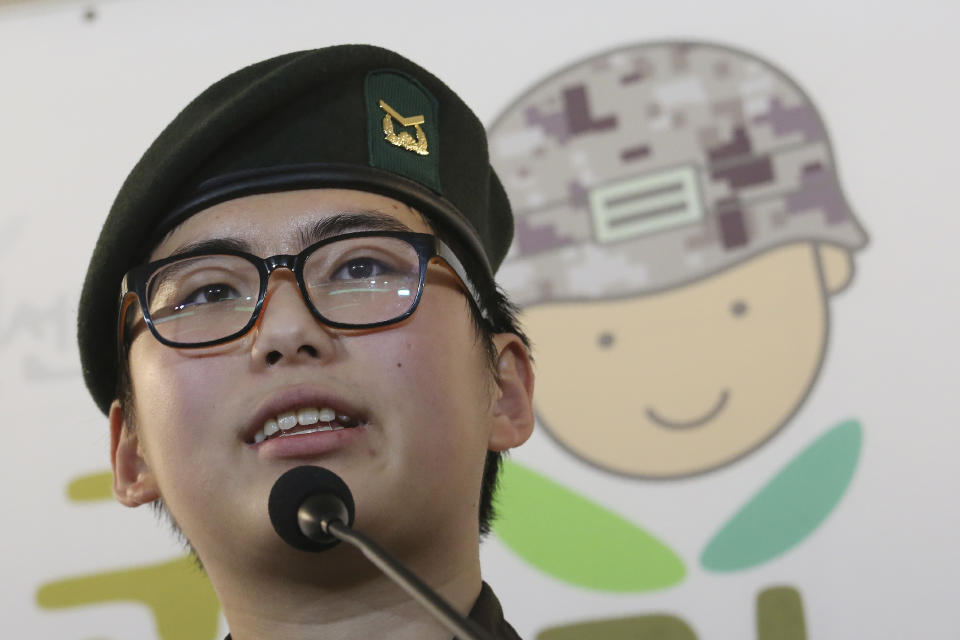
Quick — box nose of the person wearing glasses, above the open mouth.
[252,270,336,367]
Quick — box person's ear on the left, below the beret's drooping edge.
[109,400,160,507]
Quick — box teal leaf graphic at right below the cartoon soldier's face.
[700,420,862,571]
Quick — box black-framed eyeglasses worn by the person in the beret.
[120,231,483,348]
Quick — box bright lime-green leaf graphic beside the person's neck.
[494,462,685,592]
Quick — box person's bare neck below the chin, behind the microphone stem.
[207,545,481,640]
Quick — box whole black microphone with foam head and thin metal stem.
[267,465,493,640]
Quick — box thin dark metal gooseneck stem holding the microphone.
[328,519,493,640]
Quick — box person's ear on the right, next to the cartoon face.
[487,333,534,451]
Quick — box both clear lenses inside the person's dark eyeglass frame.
[147,236,420,344]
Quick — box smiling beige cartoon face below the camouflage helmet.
[522,243,853,478]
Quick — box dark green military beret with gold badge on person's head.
[78,45,513,412]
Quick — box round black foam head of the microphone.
[267,465,354,551]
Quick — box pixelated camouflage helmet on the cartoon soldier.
[489,42,866,306]
